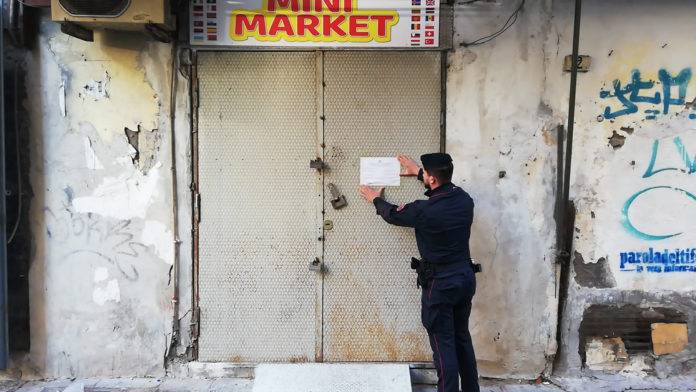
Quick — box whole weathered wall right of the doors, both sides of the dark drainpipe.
[447,0,696,377]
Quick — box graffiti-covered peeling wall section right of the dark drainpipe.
[554,0,696,377]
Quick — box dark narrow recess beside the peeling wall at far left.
[2,0,42,352]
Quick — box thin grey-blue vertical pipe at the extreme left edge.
[0,0,8,370]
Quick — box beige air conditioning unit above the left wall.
[51,0,174,31]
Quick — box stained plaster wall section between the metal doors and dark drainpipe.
[447,1,571,379]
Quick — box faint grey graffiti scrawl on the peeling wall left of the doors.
[44,207,147,281]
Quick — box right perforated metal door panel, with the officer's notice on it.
[324,52,440,361]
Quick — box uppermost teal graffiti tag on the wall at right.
[599,68,696,120]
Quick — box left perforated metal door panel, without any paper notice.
[198,52,321,362]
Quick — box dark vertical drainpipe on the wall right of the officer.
[553,0,582,369]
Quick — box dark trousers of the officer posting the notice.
[421,271,479,392]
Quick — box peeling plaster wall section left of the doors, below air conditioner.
[24,14,174,377]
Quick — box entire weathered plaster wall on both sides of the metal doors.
[19,0,696,378]
